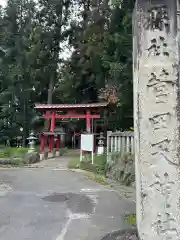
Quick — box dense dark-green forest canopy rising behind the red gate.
[0,0,134,142]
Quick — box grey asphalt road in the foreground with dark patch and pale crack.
[0,168,135,240]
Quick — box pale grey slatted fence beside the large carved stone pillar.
[107,132,134,155]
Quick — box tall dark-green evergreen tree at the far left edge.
[0,0,35,144]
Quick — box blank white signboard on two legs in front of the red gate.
[80,134,94,164]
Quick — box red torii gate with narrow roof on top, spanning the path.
[35,102,108,152]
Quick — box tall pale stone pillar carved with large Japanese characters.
[133,0,180,240]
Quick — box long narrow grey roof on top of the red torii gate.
[35,102,108,110]
